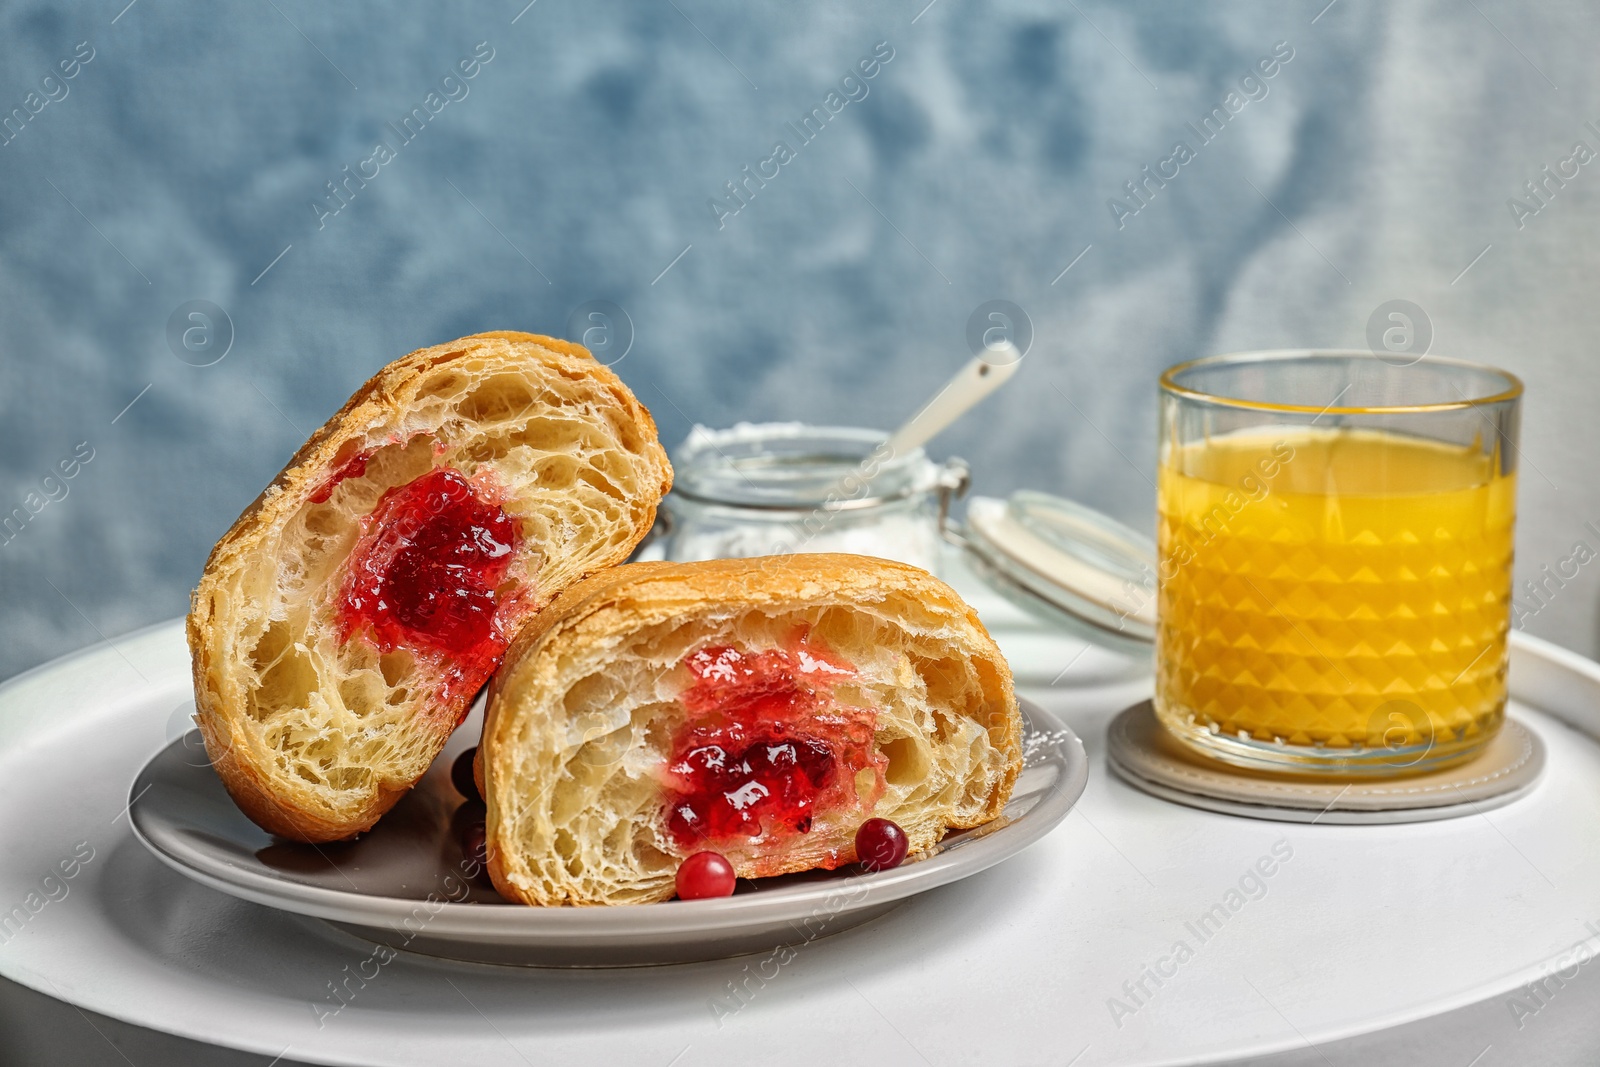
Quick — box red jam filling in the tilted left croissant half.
[339,459,520,696]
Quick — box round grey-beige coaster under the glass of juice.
[1106,701,1544,824]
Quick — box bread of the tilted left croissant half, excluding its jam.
[187,331,672,841]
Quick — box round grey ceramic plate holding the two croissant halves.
[130,701,1088,966]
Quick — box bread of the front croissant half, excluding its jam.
[477,553,1022,905]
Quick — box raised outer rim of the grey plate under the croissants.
[128,697,1090,942]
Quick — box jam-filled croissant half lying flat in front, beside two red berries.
[477,553,1022,905]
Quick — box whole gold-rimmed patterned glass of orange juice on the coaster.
[1155,350,1522,777]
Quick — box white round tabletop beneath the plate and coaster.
[0,579,1600,1067]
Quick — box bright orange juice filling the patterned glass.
[1157,427,1515,771]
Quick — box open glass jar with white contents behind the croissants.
[662,422,968,571]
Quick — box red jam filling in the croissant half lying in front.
[664,640,885,851]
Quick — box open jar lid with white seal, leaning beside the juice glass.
[946,490,1155,653]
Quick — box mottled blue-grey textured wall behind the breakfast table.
[0,0,1600,675]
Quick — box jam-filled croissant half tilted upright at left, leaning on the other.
[189,333,672,841]
